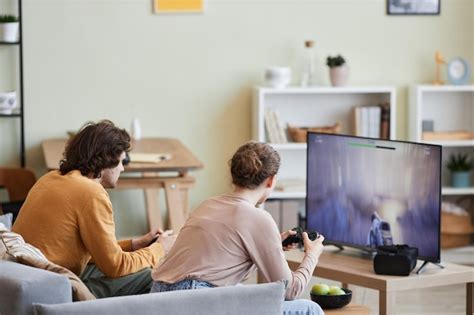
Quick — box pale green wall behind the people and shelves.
[0,0,474,234]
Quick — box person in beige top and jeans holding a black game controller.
[151,142,324,314]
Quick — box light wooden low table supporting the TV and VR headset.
[285,249,474,315]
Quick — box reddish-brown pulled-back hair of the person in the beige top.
[229,141,280,189]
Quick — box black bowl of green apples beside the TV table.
[310,283,352,309]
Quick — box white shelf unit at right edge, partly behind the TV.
[409,85,474,196]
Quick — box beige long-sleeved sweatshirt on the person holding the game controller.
[153,194,317,300]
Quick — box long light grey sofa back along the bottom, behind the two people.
[35,282,285,315]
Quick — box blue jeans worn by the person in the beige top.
[150,279,324,315]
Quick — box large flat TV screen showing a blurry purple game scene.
[306,132,441,262]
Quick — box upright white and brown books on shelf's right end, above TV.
[353,103,390,139]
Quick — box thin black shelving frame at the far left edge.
[0,0,26,167]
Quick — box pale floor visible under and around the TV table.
[246,246,474,315]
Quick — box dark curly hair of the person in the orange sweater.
[59,120,130,178]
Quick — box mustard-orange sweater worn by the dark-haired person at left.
[12,171,164,277]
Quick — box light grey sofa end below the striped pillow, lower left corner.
[0,260,72,314]
